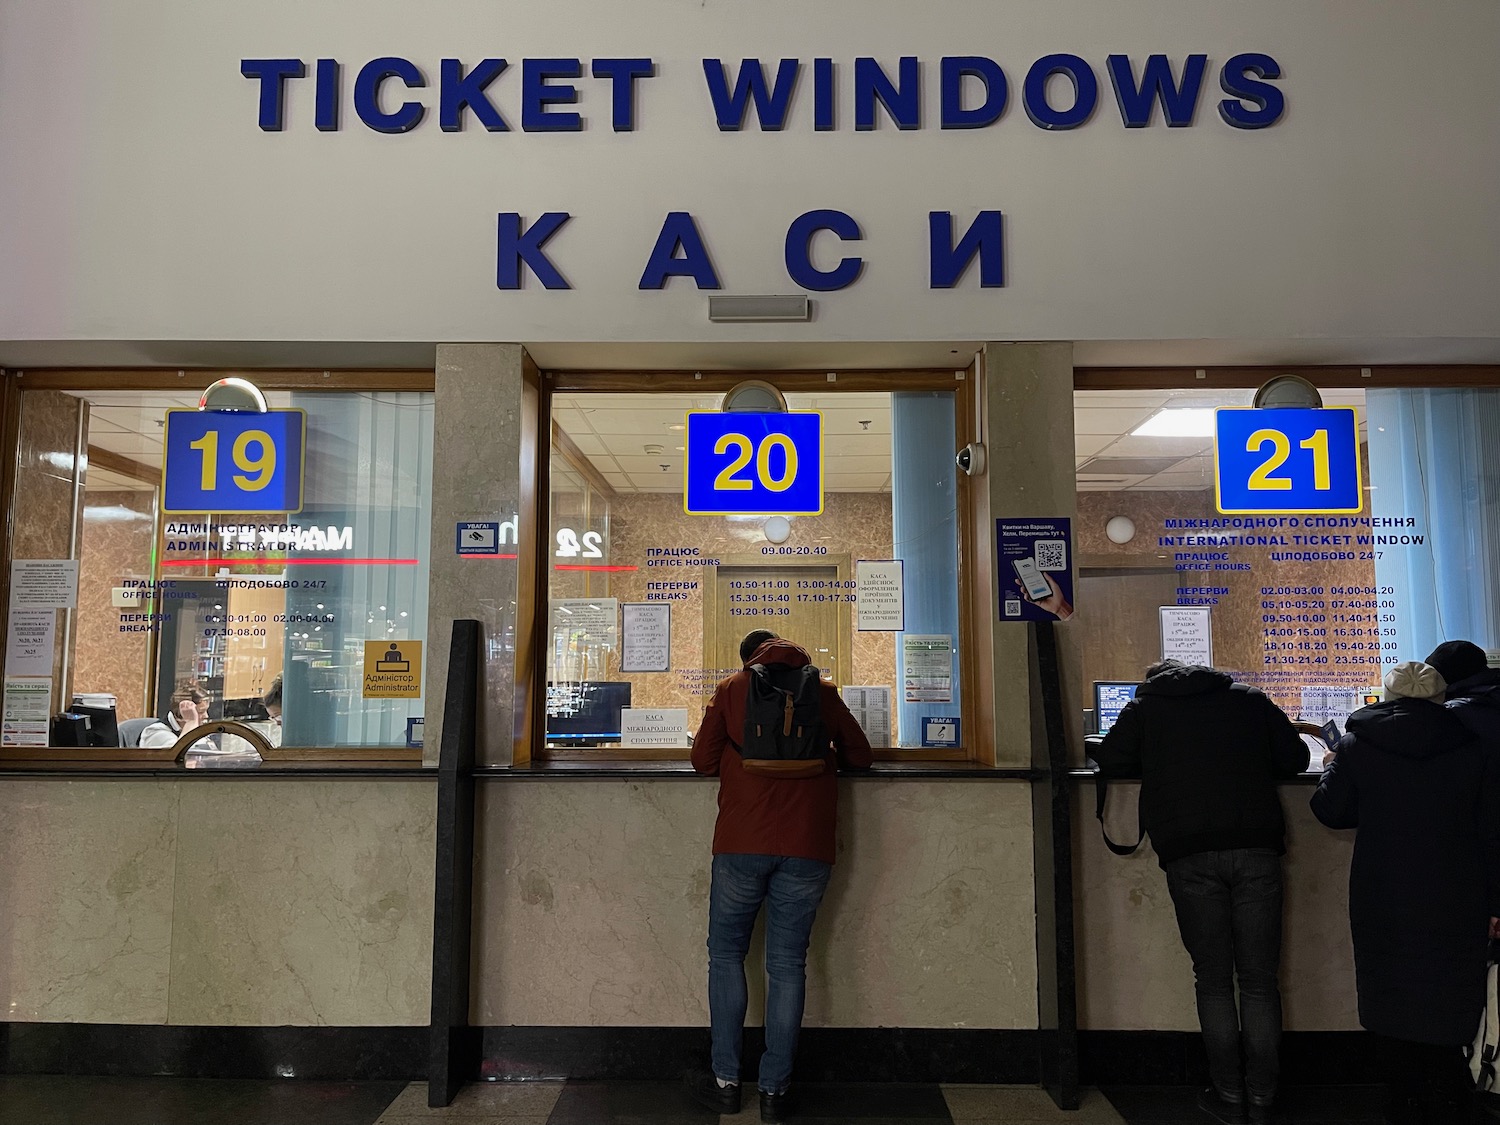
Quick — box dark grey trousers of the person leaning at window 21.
[1166,848,1283,1103]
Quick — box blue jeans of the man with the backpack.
[708,855,833,1094]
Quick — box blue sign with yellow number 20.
[683,411,824,516]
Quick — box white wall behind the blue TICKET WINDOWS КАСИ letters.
[0,0,1500,362]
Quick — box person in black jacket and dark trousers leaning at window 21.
[1097,660,1310,1122]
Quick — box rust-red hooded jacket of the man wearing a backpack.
[693,639,872,864]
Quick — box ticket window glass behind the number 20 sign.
[543,375,969,758]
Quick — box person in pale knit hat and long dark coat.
[1313,662,1500,1125]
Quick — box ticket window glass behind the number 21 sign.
[1074,380,1500,753]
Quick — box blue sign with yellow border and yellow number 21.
[1214,407,1365,516]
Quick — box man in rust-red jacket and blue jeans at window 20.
[689,629,872,1122]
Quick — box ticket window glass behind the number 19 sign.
[6,387,432,753]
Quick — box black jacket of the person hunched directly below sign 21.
[1095,665,1310,866]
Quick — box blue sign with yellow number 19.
[162,410,306,515]
